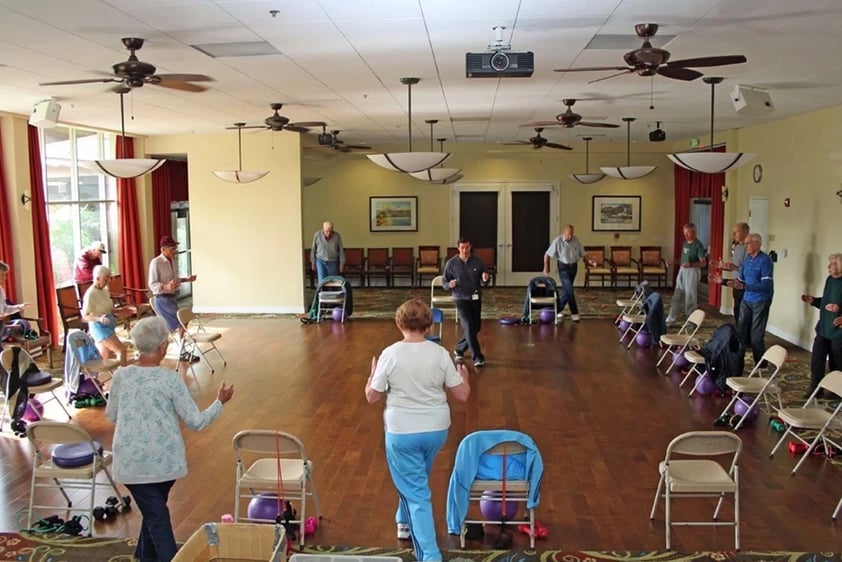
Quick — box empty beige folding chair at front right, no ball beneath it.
[649,431,743,550]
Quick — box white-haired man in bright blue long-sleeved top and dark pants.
[728,232,774,365]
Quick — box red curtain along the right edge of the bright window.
[117,137,146,296]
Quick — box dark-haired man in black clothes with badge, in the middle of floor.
[442,238,488,367]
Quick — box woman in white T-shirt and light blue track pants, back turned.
[365,299,471,560]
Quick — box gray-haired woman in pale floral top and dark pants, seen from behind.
[105,316,234,562]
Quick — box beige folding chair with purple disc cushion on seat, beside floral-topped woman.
[26,421,128,533]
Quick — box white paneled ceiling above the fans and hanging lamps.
[0,0,842,150]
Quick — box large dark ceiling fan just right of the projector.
[555,23,747,83]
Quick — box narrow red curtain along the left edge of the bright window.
[27,125,59,345]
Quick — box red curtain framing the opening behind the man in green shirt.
[673,147,725,308]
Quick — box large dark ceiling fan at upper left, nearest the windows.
[39,37,213,92]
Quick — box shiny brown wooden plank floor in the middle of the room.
[0,318,842,552]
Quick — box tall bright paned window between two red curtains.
[41,127,118,287]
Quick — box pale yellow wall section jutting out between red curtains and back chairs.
[146,132,304,313]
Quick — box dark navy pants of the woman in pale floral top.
[126,480,178,562]
